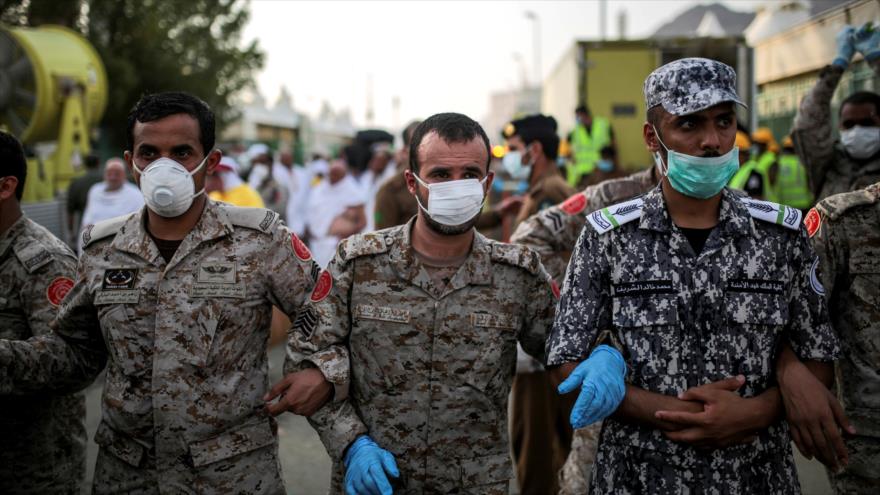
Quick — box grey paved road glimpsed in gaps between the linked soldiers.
[86,348,831,495]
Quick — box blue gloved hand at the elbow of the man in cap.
[558,345,626,428]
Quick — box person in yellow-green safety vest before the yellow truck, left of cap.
[566,105,615,189]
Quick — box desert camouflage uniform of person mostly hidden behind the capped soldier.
[510,168,657,495]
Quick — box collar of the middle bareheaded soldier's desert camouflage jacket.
[385,215,492,293]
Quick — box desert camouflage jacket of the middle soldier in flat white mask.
[285,220,555,494]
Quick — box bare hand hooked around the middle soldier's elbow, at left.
[263,368,333,416]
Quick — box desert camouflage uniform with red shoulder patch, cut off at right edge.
[807,182,880,494]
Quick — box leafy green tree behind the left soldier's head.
[0,0,265,149]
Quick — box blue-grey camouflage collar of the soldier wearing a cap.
[639,184,752,240]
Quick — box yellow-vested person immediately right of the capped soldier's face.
[728,127,779,202]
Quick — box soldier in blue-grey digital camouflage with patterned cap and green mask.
[547,58,845,493]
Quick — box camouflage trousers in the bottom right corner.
[828,435,880,494]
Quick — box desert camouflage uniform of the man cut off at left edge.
[0,216,86,494]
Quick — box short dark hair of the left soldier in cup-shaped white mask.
[125,91,215,155]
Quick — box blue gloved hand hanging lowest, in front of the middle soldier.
[345,435,400,495]
